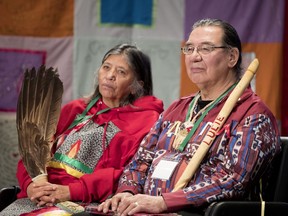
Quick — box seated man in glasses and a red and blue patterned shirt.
[98,19,280,215]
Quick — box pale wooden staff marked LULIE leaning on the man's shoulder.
[173,59,259,192]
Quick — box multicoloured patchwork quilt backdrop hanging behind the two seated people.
[0,0,288,188]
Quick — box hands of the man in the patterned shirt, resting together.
[98,194,167,216]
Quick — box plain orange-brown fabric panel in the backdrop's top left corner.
[0,0,74,37]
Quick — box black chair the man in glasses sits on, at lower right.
[205,137,288,216]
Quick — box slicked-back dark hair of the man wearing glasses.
[192,19,242,78]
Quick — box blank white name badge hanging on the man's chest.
[151,160,178,180]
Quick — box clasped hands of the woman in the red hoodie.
[27,182,70,206]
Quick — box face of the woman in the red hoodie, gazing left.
[98,55,135,107]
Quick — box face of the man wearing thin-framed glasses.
[185,26,231,89]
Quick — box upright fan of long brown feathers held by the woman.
[16,65,63,182]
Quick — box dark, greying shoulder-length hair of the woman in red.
[88,44,153,106]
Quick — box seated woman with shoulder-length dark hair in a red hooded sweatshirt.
[17,44,163,206]
